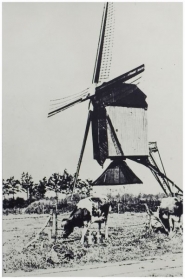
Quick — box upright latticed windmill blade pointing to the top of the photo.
[92,2,115,84]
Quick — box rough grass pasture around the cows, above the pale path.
[3,213,183,273]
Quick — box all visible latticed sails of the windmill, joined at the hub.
[48,2,144,117]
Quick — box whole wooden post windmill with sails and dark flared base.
[48,2,182,198]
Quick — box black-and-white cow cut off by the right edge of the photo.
[159,197,183,236]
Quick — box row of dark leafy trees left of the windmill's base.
[2,169,92,209]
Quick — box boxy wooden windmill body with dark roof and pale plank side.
[92,75,148,165]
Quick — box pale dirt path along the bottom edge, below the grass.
[3,253,183,277]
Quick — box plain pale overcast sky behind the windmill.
[2,3,182,193]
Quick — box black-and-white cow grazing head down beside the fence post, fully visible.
[62,197,110,244]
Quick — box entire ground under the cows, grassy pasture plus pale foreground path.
[3,213,183,277]
